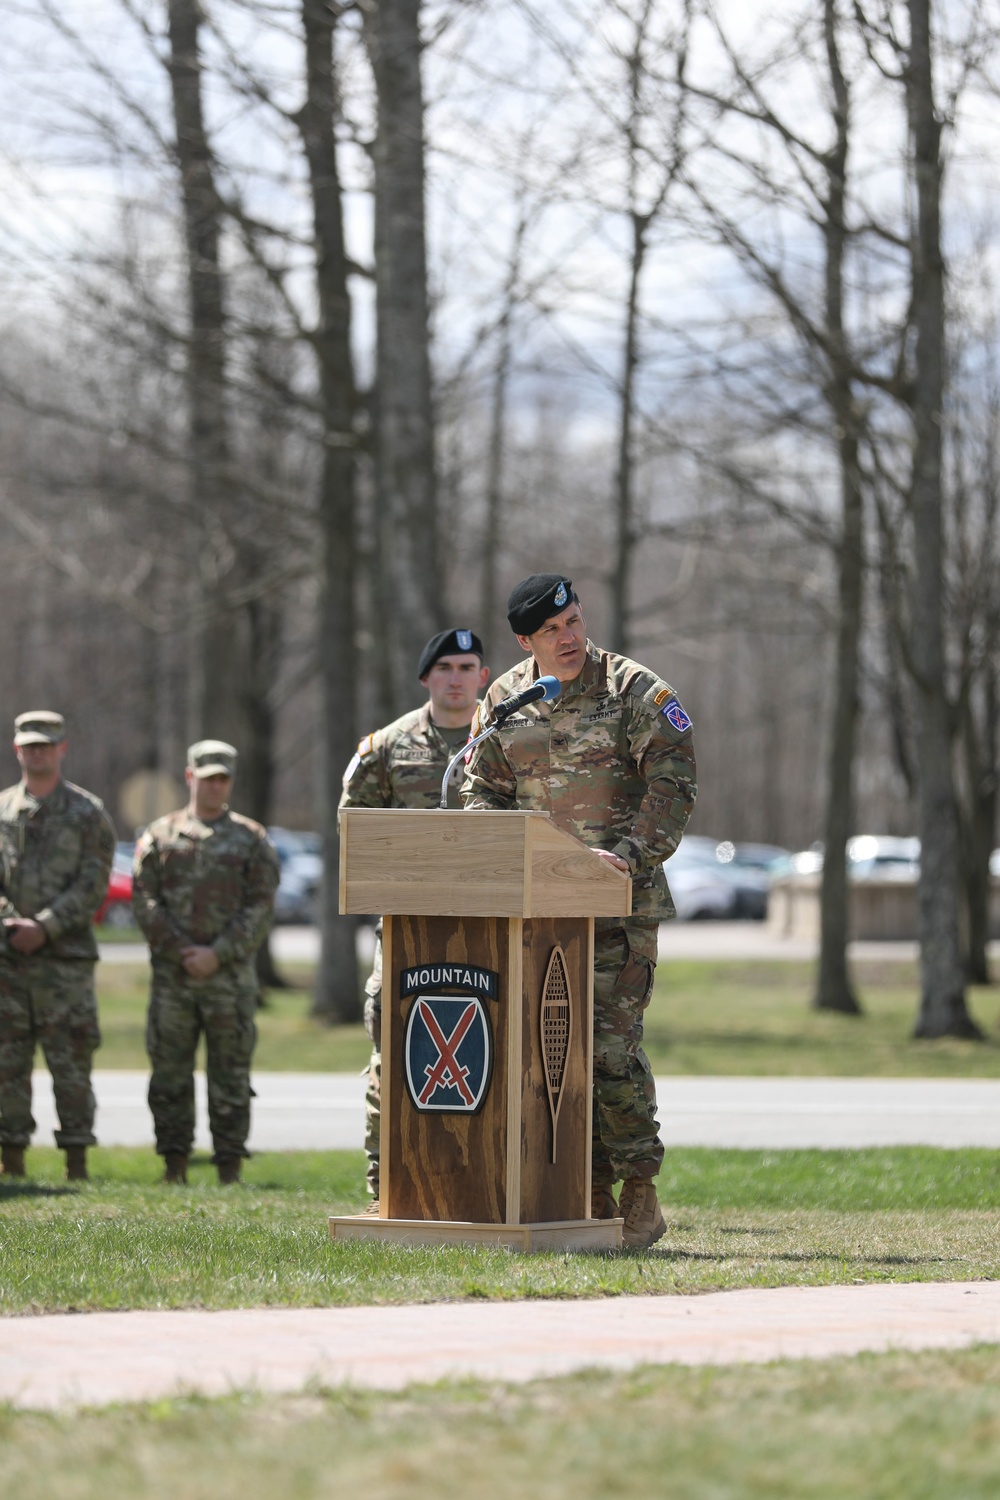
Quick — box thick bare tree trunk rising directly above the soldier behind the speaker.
[361,0,444,704]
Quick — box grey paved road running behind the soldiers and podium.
[34,1071,1000,1151]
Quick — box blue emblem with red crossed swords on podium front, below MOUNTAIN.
[403,995,493,1115]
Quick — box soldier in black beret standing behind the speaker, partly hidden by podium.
[340,630,490,1212]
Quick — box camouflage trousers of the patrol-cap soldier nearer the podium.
[145,965,259,1161]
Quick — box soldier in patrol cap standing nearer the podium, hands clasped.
[132,740,279,1184]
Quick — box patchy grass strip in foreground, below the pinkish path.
[0,1349,1000,1500]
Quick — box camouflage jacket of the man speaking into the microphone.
[462,641,697,917]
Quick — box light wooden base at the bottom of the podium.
[330,1214,625,1253]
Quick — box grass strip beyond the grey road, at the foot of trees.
[97,960,1000,1079]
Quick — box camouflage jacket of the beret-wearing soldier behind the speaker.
[340,702,468,809]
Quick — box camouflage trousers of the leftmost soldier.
[0,956,100,1151]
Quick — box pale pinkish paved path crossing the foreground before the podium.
[0,1284,1000,1409]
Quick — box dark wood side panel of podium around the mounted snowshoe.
[520,917,594,1224]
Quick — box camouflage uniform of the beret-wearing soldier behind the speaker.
[340,704,469,1197]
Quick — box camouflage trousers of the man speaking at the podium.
[592,917,663,1187]
